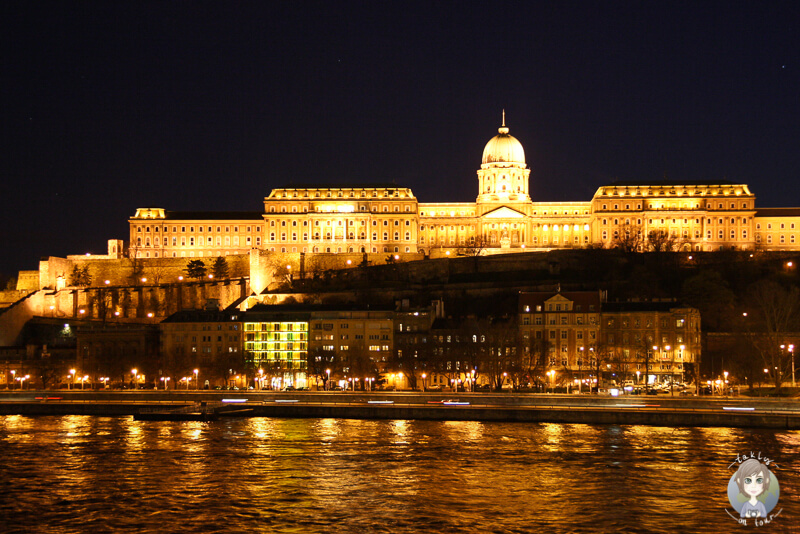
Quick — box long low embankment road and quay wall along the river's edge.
[0,390,800,430]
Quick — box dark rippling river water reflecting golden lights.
[0,416,800,533]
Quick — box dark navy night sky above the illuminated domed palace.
[0,0,800,275]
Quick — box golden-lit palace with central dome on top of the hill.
[129,117,800,258]
